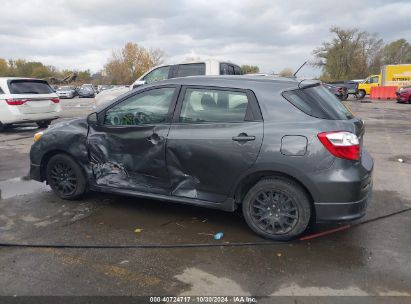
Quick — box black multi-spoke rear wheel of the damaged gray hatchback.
[242,177,311,241]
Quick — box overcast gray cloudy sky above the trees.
[0,0,411,76]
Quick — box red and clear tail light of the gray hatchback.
[317,131,361,160]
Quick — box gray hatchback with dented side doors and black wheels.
[30,76,373,240]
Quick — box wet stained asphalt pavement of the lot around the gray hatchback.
[0,99,411,303]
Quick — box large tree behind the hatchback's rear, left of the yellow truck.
[314,27,383,81]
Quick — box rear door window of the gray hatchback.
[180,89,249,123]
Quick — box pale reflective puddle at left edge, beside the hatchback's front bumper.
[0,177,51,200]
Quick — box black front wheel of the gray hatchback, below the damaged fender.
[46,154,87,200]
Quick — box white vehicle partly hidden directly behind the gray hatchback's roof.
[96,59,242,105]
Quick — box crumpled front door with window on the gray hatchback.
[88,86,179,194]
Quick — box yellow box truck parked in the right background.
[358,64,411,98]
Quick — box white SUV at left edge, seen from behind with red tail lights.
[0,77,61,131]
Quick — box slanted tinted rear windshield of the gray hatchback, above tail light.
[283,85,354,120]
